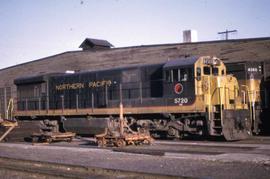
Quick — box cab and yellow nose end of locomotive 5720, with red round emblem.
[160,56,250,140]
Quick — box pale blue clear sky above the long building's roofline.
[0,0,270,68]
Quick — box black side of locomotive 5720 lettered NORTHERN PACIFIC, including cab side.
[15,60,195,111]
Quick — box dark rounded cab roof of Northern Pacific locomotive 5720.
[164,56,199,68]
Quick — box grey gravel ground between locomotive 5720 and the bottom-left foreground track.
[0,139,270,179]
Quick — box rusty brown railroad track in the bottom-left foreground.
[0,157,185,179]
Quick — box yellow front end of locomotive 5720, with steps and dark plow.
[195,56,250,140]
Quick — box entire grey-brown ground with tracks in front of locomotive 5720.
[0,137,270,179]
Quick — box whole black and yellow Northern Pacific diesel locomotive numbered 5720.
[11,56,251,140]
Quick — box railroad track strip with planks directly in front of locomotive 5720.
[8,136,270,156]
